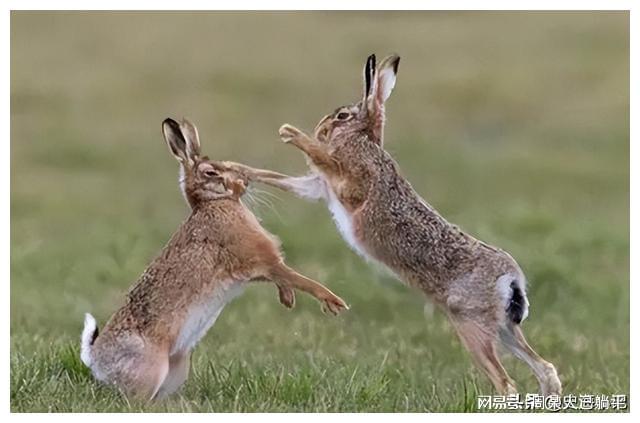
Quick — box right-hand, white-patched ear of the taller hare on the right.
[366,54,400,144]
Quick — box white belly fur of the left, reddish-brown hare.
[171,283,244,354]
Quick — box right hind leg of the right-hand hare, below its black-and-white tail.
[500,323,562,395]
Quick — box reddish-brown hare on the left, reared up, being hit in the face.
[81,119,347,399]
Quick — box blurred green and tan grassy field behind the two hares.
[10,12,630,412]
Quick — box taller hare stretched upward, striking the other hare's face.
[228,55,561,394]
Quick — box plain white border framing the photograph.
[0,0,640,423]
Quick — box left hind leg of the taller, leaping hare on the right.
[451,316,518,394]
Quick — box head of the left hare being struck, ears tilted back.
[162,118,248,208]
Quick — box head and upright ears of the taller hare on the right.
[314,54,400,145]
